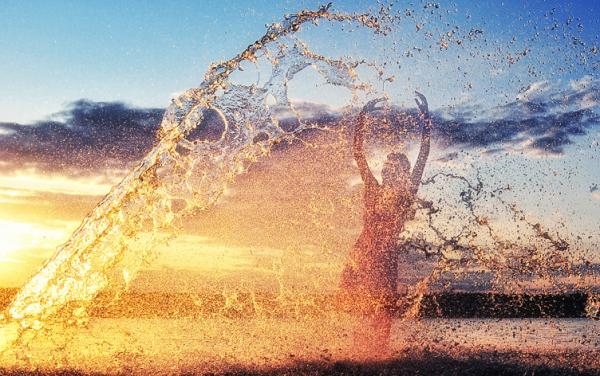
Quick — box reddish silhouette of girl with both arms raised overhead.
[341,92,432,355]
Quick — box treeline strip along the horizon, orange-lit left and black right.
[0,289,588,318]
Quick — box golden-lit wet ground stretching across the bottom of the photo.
[0,317,600,375]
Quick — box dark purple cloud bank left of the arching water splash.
[0,100,164,173]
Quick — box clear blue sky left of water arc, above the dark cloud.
[0,1,368,121]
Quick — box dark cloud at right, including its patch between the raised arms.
[296,77,600,155]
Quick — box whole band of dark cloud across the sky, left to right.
[0,77,600,174]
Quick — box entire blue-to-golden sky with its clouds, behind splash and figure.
[0,0,600,292]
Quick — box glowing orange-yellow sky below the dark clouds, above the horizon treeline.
[0,127,600,291]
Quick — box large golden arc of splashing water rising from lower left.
[1,6,380,329]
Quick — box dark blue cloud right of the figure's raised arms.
[450,76,600,154]
